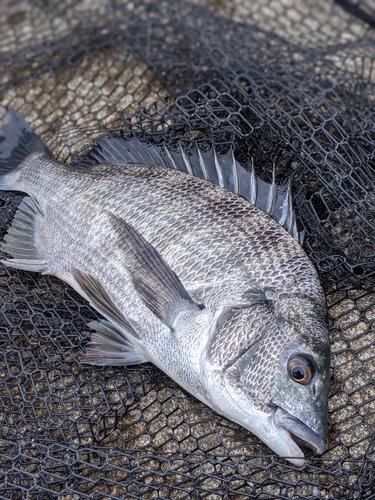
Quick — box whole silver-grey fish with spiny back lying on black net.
[0,110,330,467]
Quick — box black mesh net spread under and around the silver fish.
[0,0,375,500]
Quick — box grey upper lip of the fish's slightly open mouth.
[274,406,326,455]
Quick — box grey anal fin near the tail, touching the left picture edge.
[1,197,49,273]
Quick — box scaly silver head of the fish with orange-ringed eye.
[205,307,329,466]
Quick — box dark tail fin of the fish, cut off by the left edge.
[0,109,51,190]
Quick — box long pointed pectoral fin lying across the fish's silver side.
[109,214,201,329]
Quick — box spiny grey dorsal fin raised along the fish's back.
[74,137,304,245]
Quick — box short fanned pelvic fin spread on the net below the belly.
[81,320,147,366]
